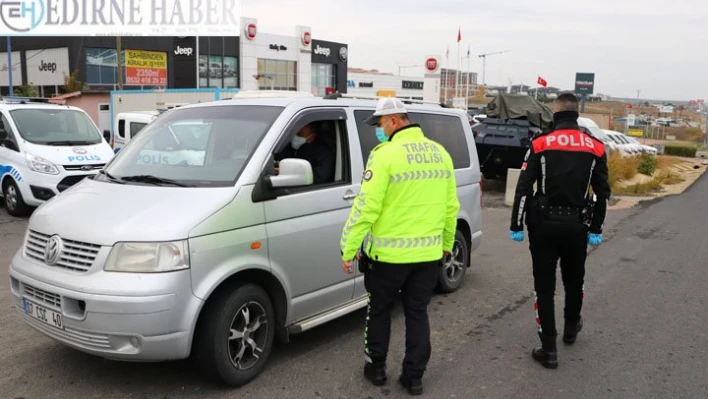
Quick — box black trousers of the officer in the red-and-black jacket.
[528,220,588,337]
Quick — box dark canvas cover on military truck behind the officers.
[487,93,553,130]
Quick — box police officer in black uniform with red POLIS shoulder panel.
[510,94,611,369]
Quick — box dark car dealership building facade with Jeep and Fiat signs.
[0,18,348,97]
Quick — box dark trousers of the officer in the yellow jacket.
[364,262,439,378]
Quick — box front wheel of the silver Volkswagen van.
[194,284,275,387]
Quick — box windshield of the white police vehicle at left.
[10,108,103,146]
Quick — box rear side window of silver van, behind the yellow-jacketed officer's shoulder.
[410,113,470,169]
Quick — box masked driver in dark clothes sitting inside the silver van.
[275,124,335,184]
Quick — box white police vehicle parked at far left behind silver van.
[0,97,114,216]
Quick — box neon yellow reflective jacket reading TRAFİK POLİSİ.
[340,125,460,264]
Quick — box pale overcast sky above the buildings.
[242,0,708,100]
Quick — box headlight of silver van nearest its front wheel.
[103,241,189,273]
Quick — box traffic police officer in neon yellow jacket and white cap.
[341,98,460,395]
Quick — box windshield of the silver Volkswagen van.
[100,105,283,187]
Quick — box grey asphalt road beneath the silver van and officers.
[0,176,708,399]
